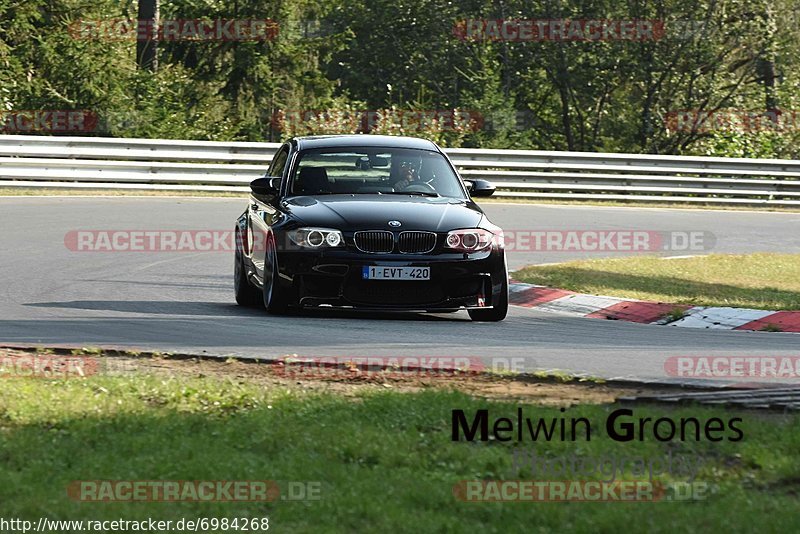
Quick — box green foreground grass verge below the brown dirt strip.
[0,376,800,533]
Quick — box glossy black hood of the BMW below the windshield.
[282,195,483,232]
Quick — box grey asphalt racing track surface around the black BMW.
[0,197,800,381]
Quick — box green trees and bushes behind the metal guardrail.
[0,0,800,158]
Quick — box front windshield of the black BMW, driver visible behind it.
[289,147,466,200]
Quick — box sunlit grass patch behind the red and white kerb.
[513,253,800,310]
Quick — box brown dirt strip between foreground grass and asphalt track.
[0,349,700,406]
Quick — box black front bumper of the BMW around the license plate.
[278,248,506,311]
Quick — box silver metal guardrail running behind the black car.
[0,135,800,206]
